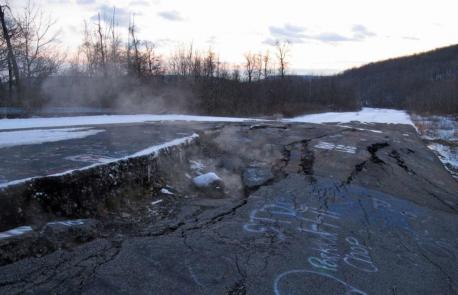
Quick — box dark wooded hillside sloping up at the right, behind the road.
[338,45,458,113]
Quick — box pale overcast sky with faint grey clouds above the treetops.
[10,0,458,73]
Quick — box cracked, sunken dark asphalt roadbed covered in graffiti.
[0,124,458,294]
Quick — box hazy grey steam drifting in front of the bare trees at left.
[42,76,197,114]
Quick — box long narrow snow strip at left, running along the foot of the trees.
[0,115,256,130]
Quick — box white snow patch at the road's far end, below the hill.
[285,108,414,126]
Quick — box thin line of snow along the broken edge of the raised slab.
[0,133,199,189]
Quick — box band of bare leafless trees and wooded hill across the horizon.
[0,3,458,116]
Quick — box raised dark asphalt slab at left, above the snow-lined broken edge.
[0,123,204,184]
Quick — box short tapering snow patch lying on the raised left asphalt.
[0,128,104,148]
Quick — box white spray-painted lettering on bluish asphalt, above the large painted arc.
[243,202,378,272]
